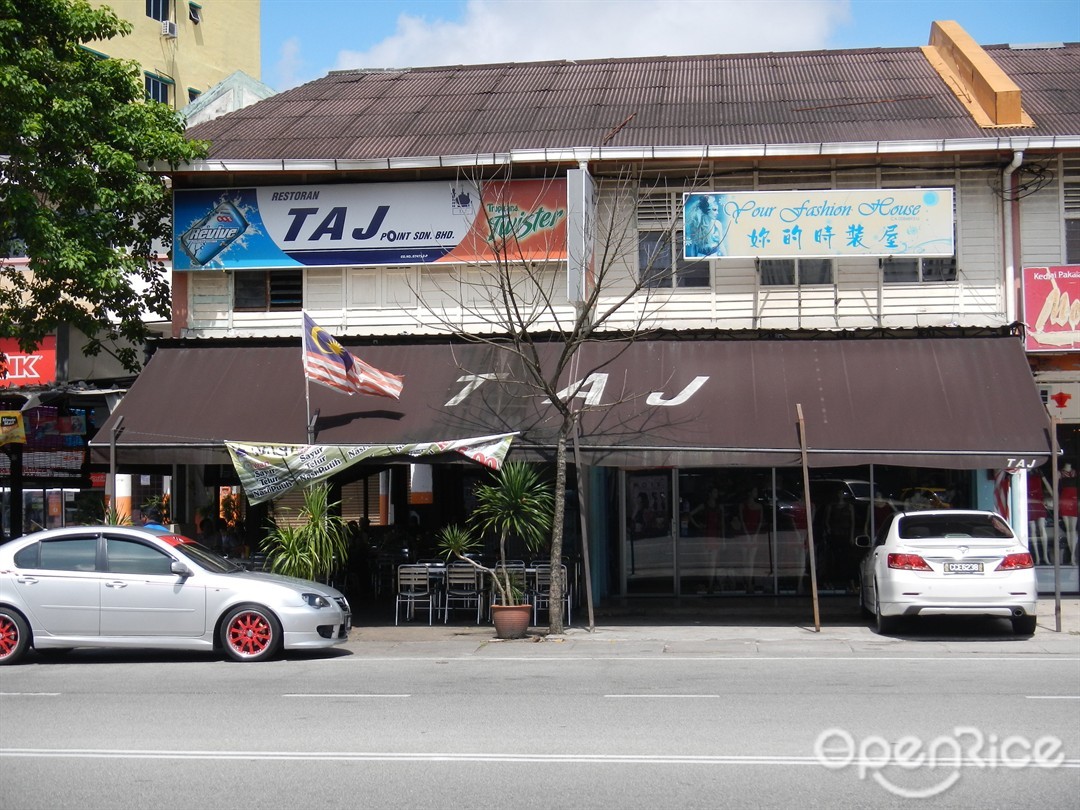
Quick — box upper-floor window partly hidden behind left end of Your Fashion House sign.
[637,191,710,288]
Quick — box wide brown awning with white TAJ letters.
[92,337,1050,469]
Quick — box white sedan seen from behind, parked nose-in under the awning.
[855,510,1038,635]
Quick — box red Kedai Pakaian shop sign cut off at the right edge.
[1023,265,1080,352]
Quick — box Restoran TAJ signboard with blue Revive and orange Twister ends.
[173,178,567,270]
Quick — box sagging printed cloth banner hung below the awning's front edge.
[225,433,516,503]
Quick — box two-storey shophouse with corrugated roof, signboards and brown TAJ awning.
[95,23,1080,598]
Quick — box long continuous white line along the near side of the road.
[0,748,1080,769]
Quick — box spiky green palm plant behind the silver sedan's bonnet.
[260,484,349,581]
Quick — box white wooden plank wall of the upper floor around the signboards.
[185,168,1064,337]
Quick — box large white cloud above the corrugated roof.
[336,0,850,69]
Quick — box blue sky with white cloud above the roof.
[259,0,1080,91]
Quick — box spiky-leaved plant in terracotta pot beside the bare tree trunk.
[438,461,555,638]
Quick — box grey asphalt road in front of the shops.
[0,627,1080,810]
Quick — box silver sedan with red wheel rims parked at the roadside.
[0,526,352,664]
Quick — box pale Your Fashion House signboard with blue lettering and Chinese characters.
[683,188,954,259]
